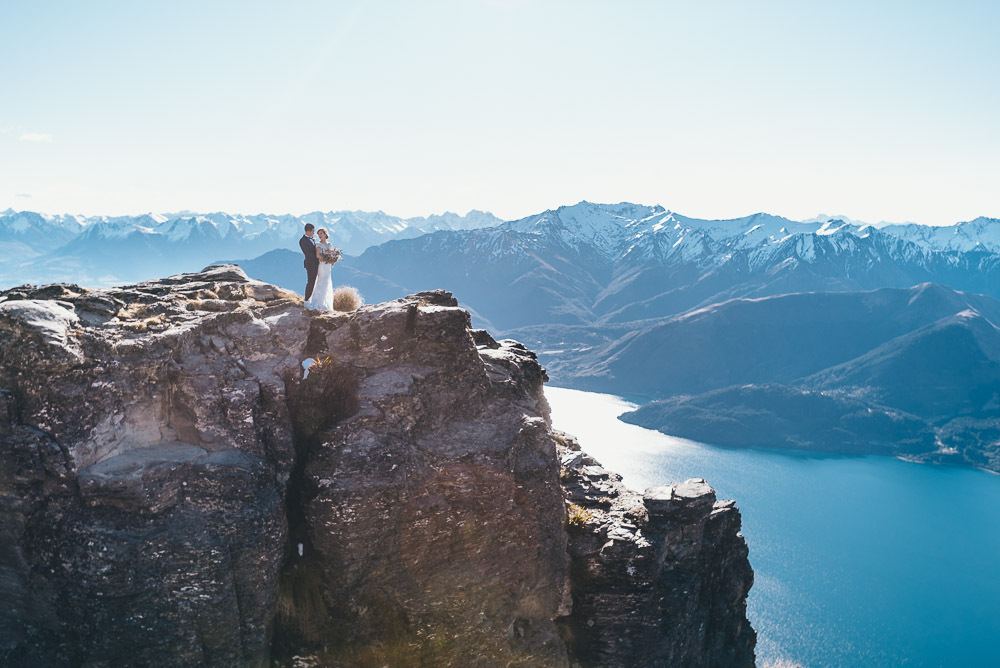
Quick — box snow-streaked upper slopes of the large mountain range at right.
[418,206,1000,288]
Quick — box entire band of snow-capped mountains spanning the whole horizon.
[0,202,1000,296]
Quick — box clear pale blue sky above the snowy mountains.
[0,0,1000,224]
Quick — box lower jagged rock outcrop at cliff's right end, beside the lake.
[562,437,756,668]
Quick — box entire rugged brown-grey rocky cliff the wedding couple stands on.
[0,266,754,666]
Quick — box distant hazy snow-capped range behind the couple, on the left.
[0,209,501,287]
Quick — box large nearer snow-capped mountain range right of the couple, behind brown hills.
[322,202,1000,338]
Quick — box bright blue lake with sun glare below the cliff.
[545,387,1000,667]
